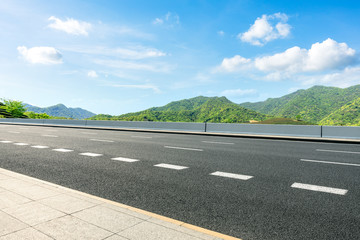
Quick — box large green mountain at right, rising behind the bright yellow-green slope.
[240,85,360,123]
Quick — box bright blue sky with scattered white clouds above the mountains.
[0,0,360,115]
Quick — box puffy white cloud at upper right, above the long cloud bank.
[238,13,291,46]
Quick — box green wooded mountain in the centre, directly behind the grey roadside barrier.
[90,96,269,123]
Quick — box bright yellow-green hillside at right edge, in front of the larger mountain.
[320,97,360,126]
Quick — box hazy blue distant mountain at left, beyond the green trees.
[25,104,95,119]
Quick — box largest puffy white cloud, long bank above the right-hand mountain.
[255,38,358,73]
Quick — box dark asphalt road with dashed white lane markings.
[0,124,360,240]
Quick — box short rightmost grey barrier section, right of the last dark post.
[322,126,360,139]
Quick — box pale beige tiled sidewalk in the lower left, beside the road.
[0,168,242,240]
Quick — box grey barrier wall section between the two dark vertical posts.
[206,123,321,137]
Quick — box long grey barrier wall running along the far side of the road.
[0,118,360,139]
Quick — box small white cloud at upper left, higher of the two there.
[48,16,91,36]
